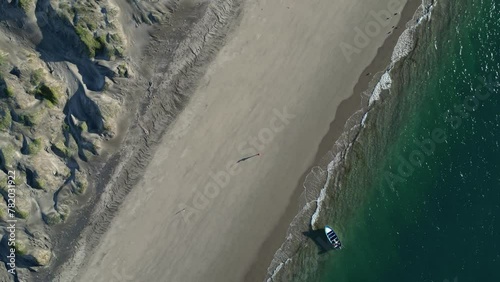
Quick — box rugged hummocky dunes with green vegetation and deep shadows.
[0,0,129,281]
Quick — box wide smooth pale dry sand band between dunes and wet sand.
[72,0,406,282]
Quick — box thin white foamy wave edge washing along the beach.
[266,0,436,282]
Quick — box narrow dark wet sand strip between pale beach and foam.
[250,0,422,282]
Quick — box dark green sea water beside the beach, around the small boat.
[270,0,500,282]
